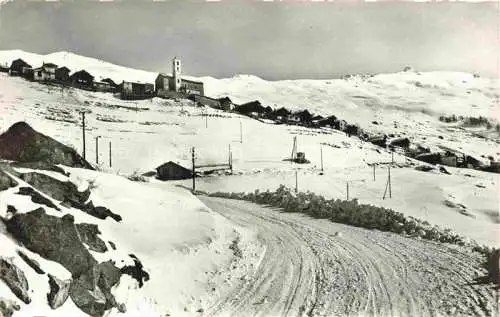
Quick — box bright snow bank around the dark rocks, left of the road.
[0,160,259,317]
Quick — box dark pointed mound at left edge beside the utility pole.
[0,122,93,169]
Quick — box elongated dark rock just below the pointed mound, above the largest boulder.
[21,173,90,204]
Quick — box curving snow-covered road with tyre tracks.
[200,196,498,316]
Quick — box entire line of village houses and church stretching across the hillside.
[0,58,500,171]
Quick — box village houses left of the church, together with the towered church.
[0,58,204,100]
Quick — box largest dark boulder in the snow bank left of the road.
[5,208,97,276]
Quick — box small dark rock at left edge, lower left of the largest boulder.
[0,257,31,304]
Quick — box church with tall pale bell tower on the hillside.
[155,58,205,98]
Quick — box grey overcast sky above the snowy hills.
[0,0,500,80]
